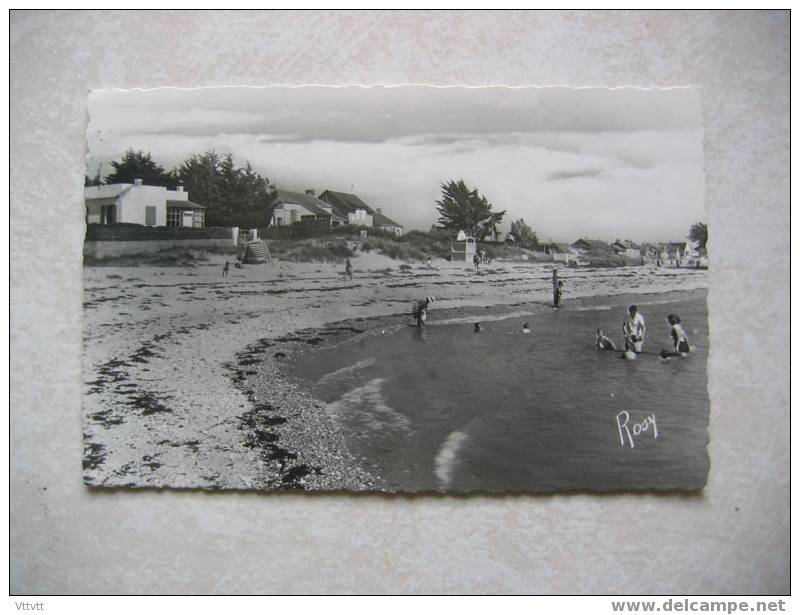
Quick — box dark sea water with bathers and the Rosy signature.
[292,298,709,491]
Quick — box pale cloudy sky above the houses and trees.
[87,86,705,241]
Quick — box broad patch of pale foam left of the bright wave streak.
[328,378,411,437]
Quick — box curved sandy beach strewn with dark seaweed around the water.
[83,253,707,490]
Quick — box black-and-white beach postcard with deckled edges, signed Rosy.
[83,86,709,493]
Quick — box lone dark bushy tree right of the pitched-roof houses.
[436,179,506,240]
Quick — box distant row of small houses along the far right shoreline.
[544,238,706,267]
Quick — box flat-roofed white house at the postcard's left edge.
[84,179,206,227]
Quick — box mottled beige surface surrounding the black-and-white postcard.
[10,12,789,593]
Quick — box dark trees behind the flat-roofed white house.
[86,150,276,227]
